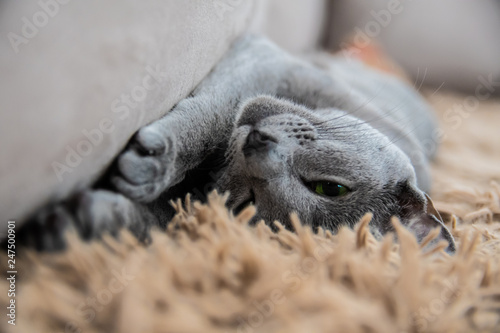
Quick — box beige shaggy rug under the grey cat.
[0,92,500,333]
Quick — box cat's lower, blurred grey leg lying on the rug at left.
[17,190,158,251]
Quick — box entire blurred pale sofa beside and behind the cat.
[0,0,500,236]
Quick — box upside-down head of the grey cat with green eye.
[219,96,454,251]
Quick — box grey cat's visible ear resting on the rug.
[398,183,456,254]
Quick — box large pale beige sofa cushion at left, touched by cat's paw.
[0,0,263,232]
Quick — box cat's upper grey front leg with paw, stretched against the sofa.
[111,37,289,202]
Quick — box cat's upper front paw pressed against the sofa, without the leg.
[111,123,177,202]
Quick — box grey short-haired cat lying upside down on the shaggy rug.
[15,35,455,253]
